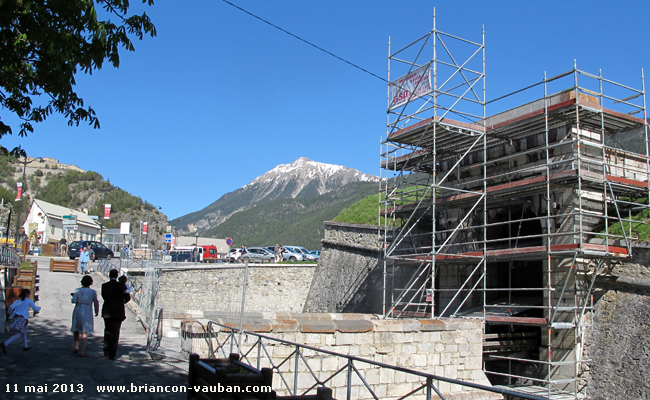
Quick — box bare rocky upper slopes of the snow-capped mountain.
[171,157,379,233]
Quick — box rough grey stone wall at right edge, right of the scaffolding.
[582,245,650,400]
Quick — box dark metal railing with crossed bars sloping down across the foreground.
[177,321,545,400]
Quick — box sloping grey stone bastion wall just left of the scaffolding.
[304,221,384,314]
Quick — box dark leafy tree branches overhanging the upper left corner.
[0,0,156,156]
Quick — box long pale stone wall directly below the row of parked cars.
[157,264,316,316]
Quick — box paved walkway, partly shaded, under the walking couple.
[0,257,187,400]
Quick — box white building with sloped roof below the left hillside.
[23,199,100,244]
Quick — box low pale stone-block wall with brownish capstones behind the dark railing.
[182,313,492,400]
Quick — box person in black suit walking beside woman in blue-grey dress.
[102,269,131,360]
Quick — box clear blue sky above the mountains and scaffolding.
[0,0,650,219]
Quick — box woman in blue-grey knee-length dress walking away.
[70,275,99,358]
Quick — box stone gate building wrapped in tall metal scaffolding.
[380,18,650,399]
